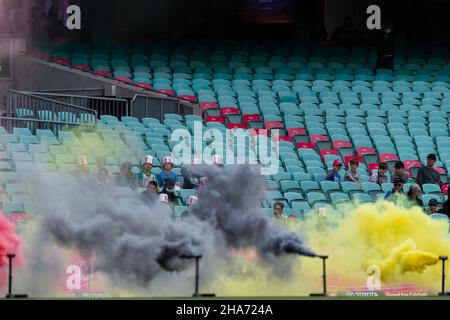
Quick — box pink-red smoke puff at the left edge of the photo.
[0,210,23,288]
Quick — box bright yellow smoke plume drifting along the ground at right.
[208,201,450,296]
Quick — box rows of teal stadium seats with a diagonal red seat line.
[6,41,450,220]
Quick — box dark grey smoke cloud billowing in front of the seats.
[30,165,314,288]
